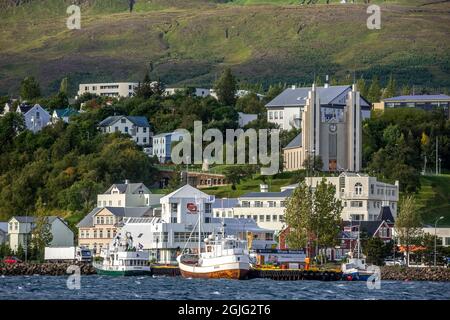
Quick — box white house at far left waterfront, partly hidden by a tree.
[8,216,74,251]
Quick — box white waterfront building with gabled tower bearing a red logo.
[120,185,275,263]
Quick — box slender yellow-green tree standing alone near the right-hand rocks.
[395,195,422,266]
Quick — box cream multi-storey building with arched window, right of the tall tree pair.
[281,172,399,221]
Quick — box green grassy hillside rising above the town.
[0,0,450,94]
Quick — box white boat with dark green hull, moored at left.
[93,233,151,276]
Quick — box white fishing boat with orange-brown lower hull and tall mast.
[177,199,250,279]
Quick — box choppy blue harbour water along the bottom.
[0,275,450,300]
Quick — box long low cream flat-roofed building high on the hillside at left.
[78,82,139,98]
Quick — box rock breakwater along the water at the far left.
[0,263,96,276]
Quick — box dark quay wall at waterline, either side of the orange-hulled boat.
[151,266,342,281]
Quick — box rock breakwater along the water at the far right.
[381,266,450,281]
